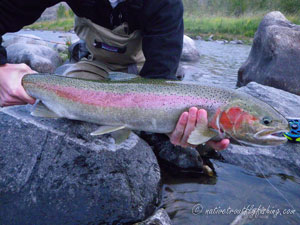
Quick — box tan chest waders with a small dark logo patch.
[64,17,145,80]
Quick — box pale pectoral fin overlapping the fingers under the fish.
[187,124,218,145]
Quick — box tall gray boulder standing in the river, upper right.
[237,12,300,95]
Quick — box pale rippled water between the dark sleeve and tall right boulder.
[183,41,251,88]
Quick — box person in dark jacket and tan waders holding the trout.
[0,0,229,149]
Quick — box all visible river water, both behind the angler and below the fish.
[4,31,300,225]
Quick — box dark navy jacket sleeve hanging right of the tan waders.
[140,0,183,79]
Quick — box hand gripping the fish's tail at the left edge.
[0,63,36,107]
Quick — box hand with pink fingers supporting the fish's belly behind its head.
[168,107,230,150]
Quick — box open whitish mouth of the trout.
[254,129,288,143]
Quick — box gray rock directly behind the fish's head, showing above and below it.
[221,82,300,176]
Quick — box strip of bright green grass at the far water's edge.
[26,13,300,42]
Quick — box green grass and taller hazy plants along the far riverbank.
[27,0,300,40]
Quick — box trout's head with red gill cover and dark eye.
[215,98,289,146]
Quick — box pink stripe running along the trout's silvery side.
[42,84,219,109]
